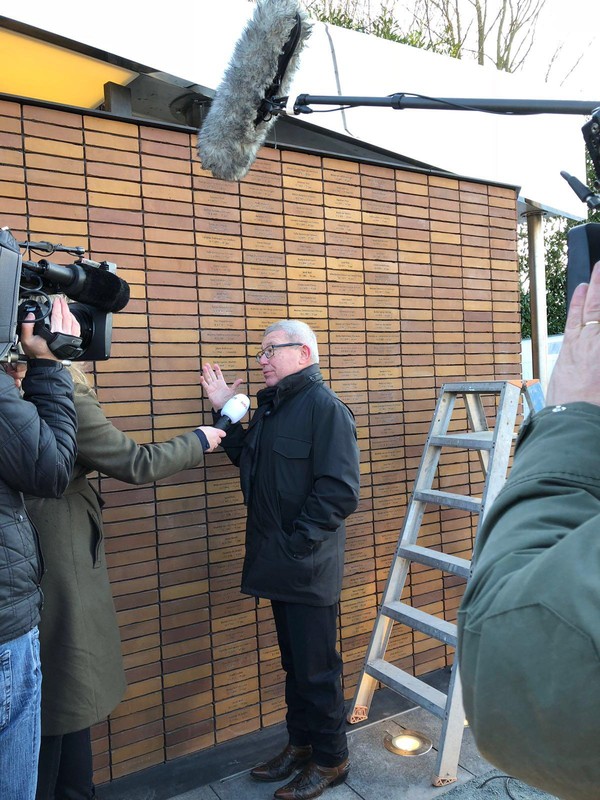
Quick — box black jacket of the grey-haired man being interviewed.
[223,364,360,606]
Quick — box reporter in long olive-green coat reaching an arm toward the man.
[21,368,225,800]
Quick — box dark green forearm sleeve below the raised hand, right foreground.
[465,403,600,605]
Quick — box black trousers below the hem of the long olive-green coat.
[35,728,96,800]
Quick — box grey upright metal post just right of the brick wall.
[526,211,548,391]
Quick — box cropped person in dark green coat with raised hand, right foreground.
[458,262,600,800]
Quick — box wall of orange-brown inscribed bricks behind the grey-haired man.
[0,101,520,782]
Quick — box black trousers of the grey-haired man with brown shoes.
[271,600,348,767]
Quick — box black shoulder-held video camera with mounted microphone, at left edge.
[0,228,129,361]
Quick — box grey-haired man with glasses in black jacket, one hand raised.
[202,320,360,800]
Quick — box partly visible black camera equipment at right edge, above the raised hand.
[561,108,600,308]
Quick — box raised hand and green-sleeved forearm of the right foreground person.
[463,268,600,613]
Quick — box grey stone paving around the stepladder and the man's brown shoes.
[168,708,491,800]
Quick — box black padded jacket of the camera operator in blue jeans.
[0,359,77,644]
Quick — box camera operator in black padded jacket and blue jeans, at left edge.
[0,300,79,800]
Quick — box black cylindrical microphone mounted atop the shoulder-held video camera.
[23,258,129,313]
